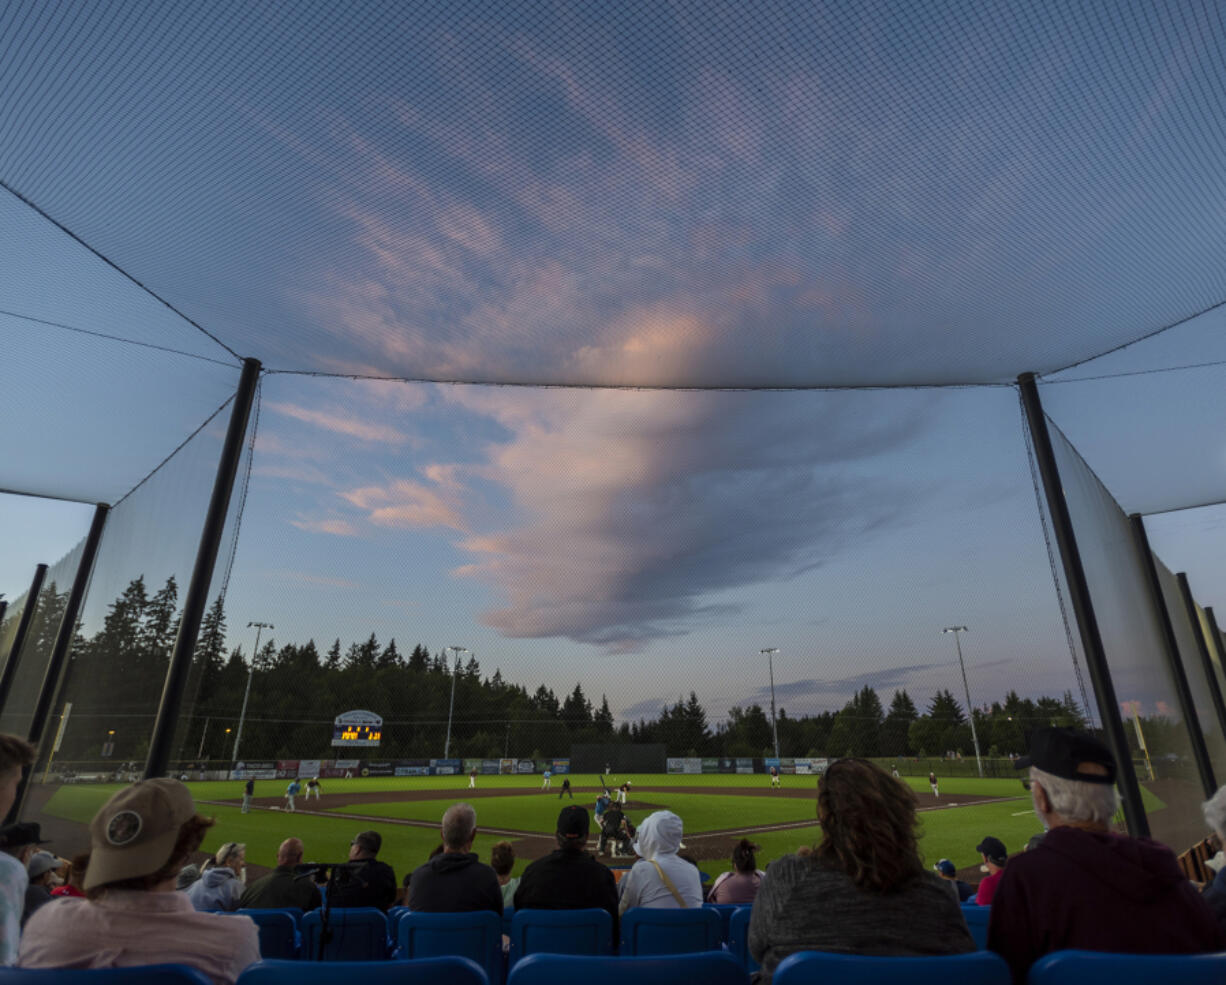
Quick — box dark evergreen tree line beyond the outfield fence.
[0,577,1123,762]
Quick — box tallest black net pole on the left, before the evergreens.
[145,359,260,779]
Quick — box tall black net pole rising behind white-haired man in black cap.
[1018,373,1150,838]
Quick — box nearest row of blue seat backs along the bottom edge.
[7,951,1226,985]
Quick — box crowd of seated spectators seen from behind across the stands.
[0,729,1226,985]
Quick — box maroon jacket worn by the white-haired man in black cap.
[988,828,1226,983]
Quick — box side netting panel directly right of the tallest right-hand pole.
[1048,424,1213,850]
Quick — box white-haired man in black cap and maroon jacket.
[988,729,1226,983]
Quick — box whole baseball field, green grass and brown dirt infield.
[32,774,1038,876]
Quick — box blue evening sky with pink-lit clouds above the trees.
[0,0,1226,715]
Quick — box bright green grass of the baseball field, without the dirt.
[44,774,1038,875]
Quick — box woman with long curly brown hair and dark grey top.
[749,759,975,985]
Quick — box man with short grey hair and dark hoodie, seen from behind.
[408,803,503,915]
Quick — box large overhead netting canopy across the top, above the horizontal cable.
[0,0,1226,386]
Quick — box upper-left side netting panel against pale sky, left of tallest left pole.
[0,191,238,503]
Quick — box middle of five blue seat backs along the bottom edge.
[506,951,749,985]
